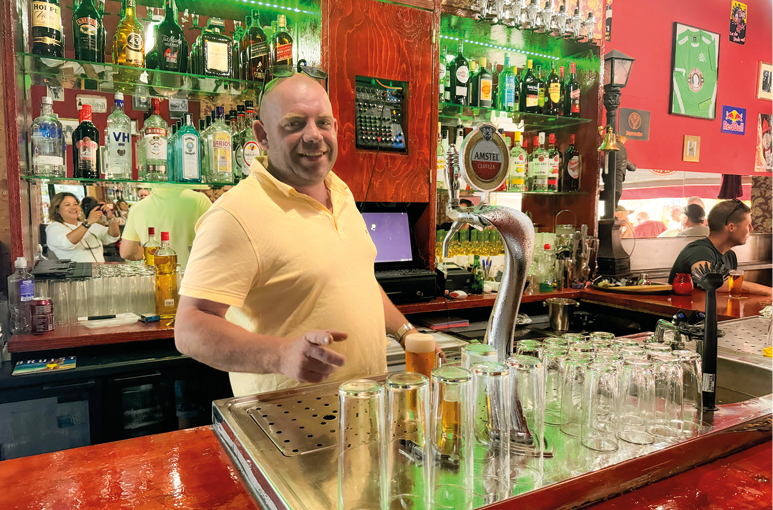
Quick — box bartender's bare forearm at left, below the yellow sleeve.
[174,309,286,374]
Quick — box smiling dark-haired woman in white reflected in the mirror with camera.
[46,193,121,262]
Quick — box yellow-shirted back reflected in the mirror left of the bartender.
[120,188,212,269]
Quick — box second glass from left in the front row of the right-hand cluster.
[617,357,655,445]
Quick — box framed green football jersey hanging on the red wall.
[669,23,719,119]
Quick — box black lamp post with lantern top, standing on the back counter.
[597,50,634,275]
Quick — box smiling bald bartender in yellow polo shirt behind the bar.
[175,74,440,396]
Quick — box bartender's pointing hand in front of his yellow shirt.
[279,329,349,383]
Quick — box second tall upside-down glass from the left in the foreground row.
[385,372,429,510]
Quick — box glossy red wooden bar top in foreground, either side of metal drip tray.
[0,427,773,510]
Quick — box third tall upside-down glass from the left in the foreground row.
[428,366,473,510]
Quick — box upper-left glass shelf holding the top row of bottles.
[16,53,262,100]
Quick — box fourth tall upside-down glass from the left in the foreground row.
[471,362,511,508]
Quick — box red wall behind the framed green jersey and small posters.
[606,0,773,175]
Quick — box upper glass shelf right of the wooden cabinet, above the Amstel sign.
[438,103,591,131]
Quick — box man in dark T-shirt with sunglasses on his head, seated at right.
[668,199,772,295]
